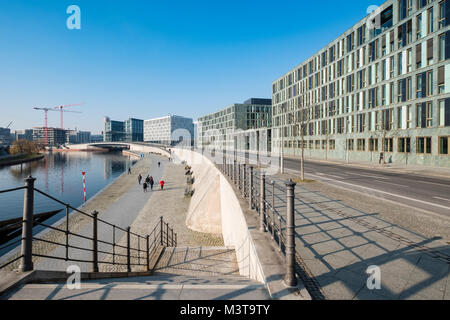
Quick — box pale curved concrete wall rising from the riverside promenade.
[173,149,265,283]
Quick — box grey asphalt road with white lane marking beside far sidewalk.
[284,159,450,217]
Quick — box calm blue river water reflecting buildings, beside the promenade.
[0,152,136,221]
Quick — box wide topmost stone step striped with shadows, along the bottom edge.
[2,273,270,300]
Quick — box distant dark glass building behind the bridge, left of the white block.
[103,117,144,142]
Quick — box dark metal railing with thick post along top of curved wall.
[216,157,297,287]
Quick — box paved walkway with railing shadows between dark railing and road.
[267,172,450,300]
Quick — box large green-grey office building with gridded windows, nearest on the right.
[272,0,450,166]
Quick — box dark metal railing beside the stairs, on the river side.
[0,176,177,272]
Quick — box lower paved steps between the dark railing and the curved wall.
[154,247,239,276]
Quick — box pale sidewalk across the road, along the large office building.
[285,156,450,179]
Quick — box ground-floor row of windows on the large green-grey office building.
[284,136,450,155]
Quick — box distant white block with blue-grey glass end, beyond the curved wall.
[144,115,194,145]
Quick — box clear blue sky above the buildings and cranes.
[0,0,383,133]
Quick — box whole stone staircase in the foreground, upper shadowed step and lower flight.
[0,247,270,300]
